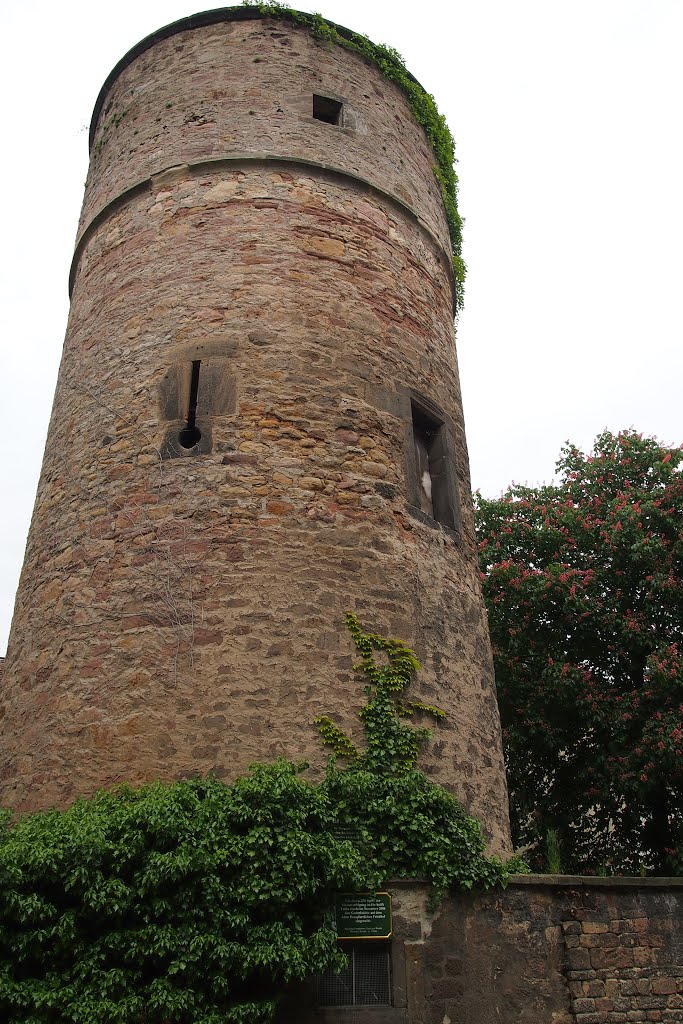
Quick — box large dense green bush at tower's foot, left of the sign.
[0,761,352,1024]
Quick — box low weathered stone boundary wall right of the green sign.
[296,874,683,1024]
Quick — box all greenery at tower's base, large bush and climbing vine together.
[0,615,516,1024]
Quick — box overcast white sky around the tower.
[0,0,683,650]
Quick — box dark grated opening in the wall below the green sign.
[316,941,391,1007]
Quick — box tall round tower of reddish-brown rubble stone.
[0,8,509,852]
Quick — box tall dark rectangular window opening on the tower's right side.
[413,404,456,528]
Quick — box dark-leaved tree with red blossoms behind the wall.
[476,431,683,874]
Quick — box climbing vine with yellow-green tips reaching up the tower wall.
[315,613,516,906]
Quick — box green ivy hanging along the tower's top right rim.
[237,0,467,309]
